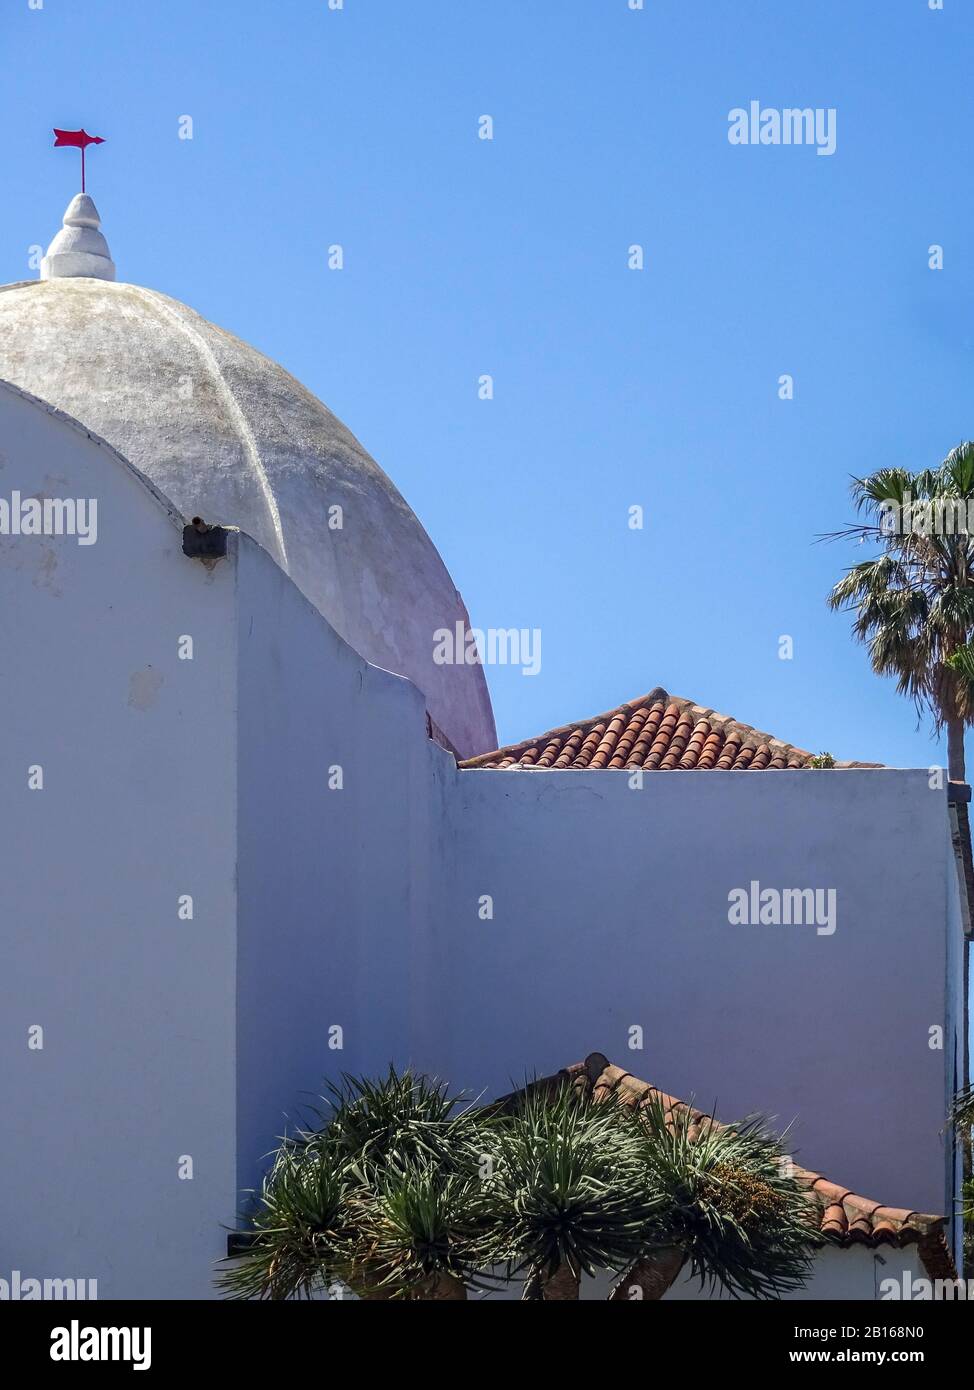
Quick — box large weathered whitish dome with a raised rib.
[0,199,496,756]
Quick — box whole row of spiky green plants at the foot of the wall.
[218,1069,818,1298]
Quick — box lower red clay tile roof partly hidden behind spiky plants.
[500,1052,957,1279]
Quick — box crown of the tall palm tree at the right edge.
[828,442,974,781]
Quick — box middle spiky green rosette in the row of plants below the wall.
[485,1084,659,1301]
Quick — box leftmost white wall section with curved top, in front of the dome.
[0,384,236,1298]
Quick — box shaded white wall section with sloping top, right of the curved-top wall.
[238,537,456,1186]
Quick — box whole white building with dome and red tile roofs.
[0,199,974,1298]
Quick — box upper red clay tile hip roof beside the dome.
[459,685,878,771]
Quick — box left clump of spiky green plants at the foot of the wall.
[218,1066,481,1298]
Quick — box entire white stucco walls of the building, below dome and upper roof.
[0,385,960,1297]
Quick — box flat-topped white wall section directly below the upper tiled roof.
[438,771,953,1212]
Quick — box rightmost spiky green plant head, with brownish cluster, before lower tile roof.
[611,1091,821,1301]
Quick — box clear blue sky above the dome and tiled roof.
[0,0,974,766]
